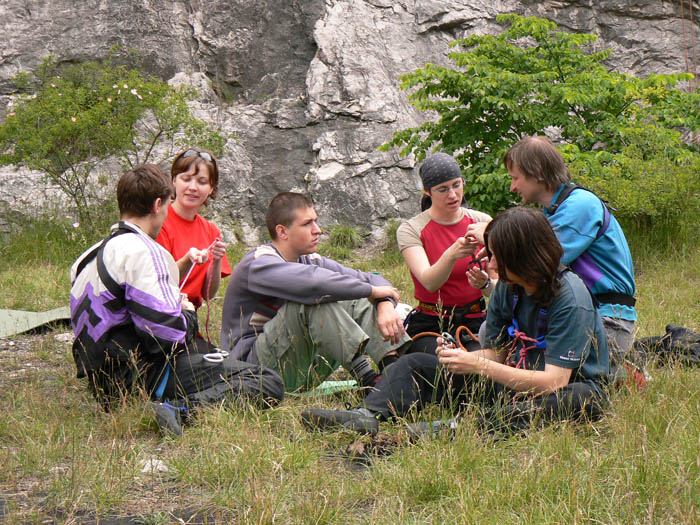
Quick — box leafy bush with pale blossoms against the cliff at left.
[0,50,225,226]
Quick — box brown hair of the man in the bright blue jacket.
[503,136,571,191]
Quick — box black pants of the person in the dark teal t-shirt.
[365,354,605,432]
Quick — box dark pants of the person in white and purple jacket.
[88,338,284,410]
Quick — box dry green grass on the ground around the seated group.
[0,212,700,524]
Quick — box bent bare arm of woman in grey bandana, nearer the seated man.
[401,237,476,292]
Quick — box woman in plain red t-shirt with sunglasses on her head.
[156,148,231,308]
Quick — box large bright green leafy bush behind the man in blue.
[382,14,700,219]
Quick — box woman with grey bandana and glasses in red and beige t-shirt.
[397,153,492,353]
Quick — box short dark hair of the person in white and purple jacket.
[117,164,175,217]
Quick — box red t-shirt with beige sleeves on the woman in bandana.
[397,210,491,306]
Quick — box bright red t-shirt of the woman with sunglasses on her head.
[156,206,231,308]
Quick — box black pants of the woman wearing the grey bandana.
[406,310,486,355]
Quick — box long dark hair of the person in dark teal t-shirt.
[484,206,564,306]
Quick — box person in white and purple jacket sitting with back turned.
[70,164,284,434]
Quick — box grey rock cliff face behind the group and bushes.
[0,0,700,243]
